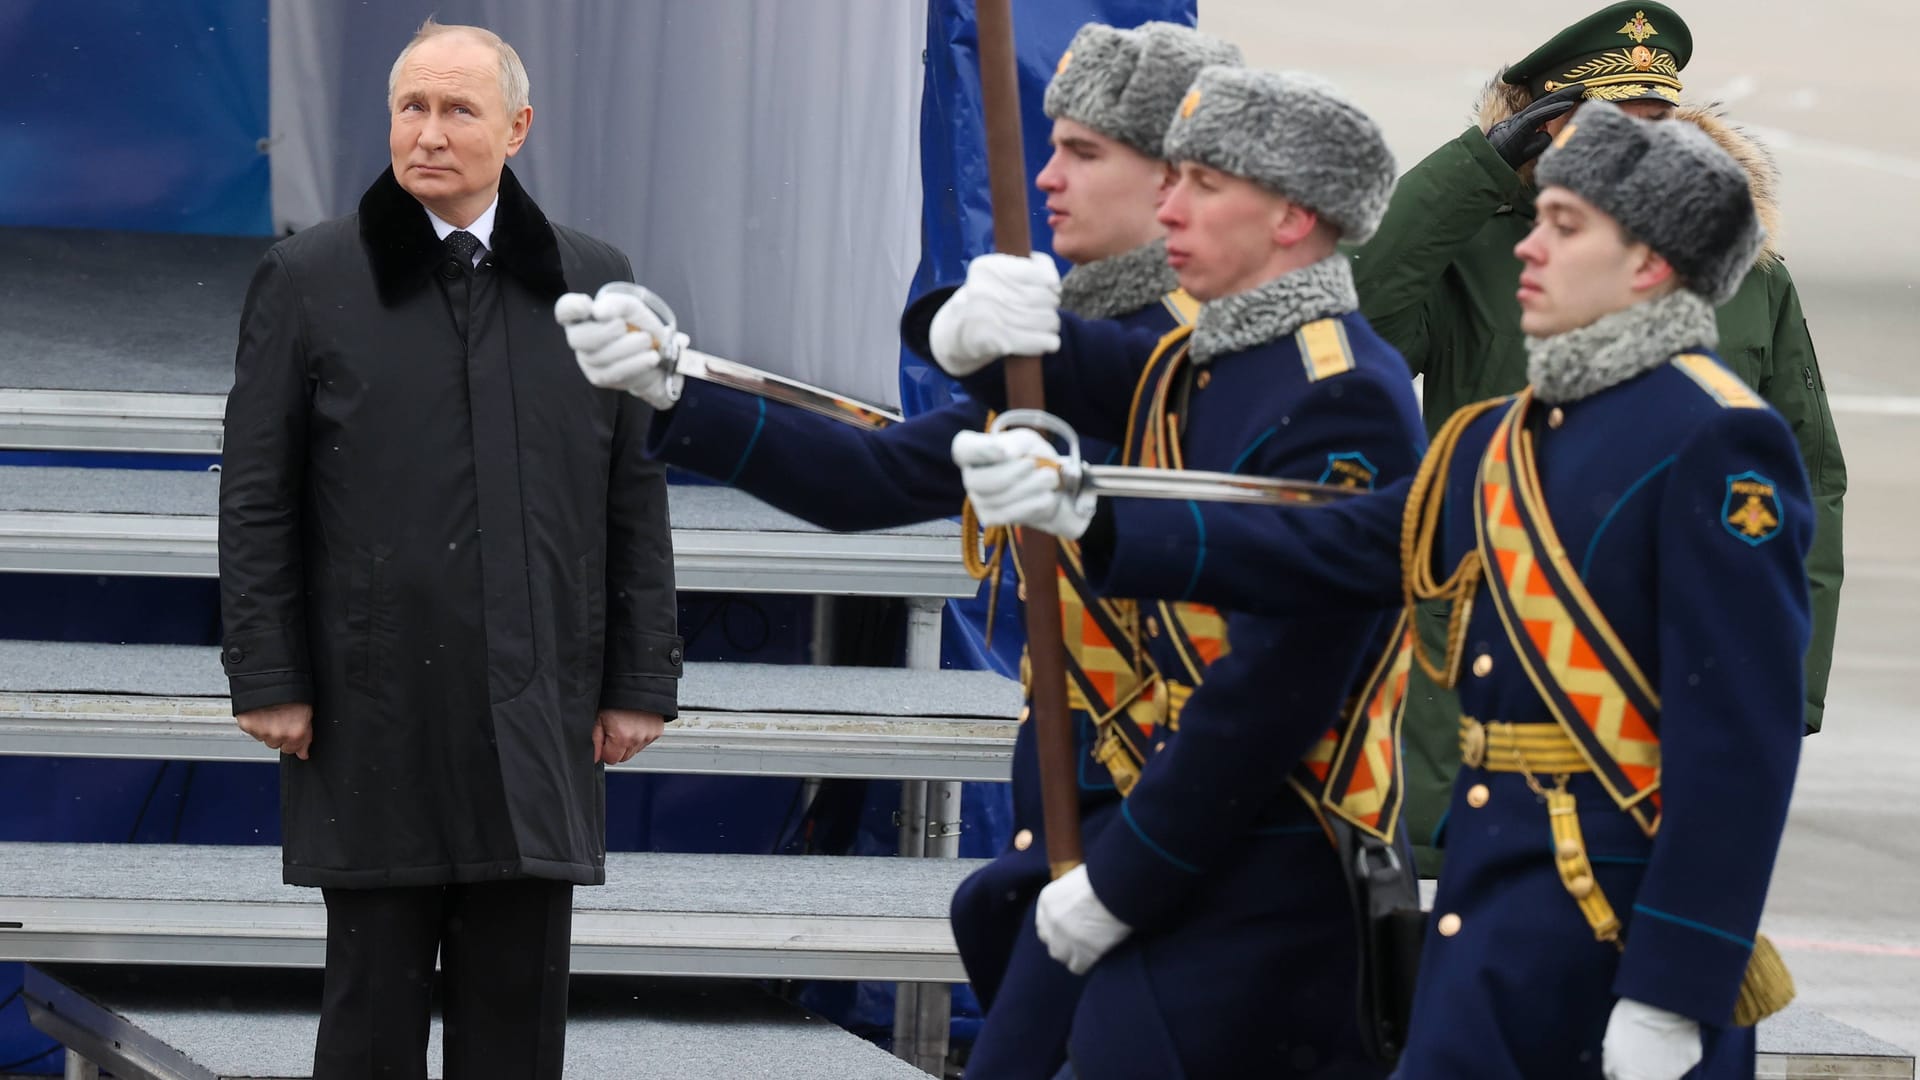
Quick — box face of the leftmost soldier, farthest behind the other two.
[1035,117,1167,263]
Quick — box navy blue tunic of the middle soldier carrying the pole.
[966,255,1425,1078]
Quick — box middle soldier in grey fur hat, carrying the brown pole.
[925,67,1425,1080]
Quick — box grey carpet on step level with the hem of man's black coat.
[0,844,981,920]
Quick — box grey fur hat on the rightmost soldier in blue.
[1534,102,1766,304]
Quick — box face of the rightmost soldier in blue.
[1513,186,1672,338]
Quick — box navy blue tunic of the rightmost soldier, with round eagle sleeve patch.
[1108,354,1812,1080]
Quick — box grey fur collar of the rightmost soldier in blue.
[1526,288,1720,404]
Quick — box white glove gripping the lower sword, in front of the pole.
[952,427,1098,540]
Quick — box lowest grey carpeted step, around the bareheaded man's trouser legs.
[30,967,925,1080]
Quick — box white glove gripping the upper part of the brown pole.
[927,252,1060,379]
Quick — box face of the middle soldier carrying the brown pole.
[1160,161,1290,302]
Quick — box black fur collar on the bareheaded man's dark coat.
[359,167,566,306]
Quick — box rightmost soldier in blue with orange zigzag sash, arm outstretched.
[967,102,1812,1080]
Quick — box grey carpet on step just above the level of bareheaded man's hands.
[0,640,1021,719]
